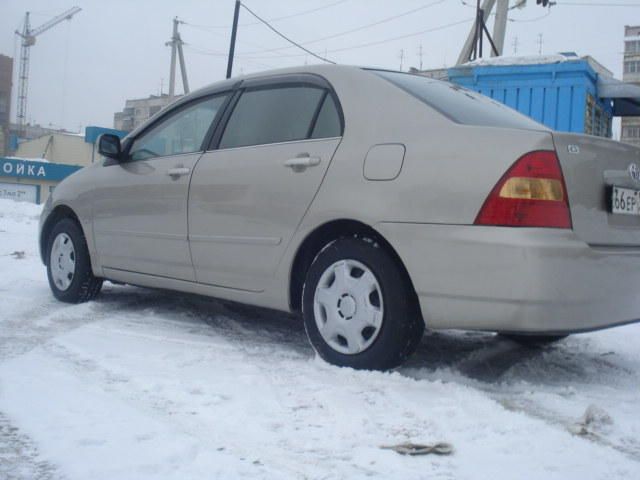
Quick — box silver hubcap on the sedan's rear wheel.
[313,260,384,355]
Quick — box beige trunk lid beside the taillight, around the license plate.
[553,132,640,246]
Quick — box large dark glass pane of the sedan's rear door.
[218,86,326,148]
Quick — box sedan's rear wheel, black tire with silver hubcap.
[302,237,424,370]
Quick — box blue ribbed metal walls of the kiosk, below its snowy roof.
[448,59,613,137]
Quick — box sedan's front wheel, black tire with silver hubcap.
[47,218,102,303]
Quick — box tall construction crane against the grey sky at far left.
[16,7,82,135]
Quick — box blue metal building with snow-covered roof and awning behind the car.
[447,54,640,137]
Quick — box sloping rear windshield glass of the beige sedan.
[370,70,547,130]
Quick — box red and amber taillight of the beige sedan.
[475,150,571,228]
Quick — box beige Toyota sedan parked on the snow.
[40,66,640,369]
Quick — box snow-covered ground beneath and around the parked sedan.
[0,200,640,480]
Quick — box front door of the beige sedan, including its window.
[93,94,227,281]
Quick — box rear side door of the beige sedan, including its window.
[189,75,343,291]
